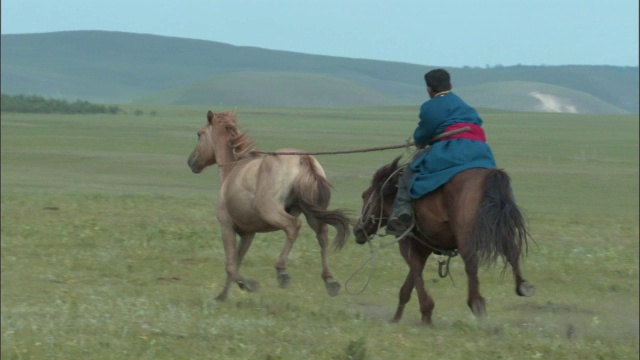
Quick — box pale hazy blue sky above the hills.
[1,0,639,67]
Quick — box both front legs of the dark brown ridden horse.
[391,238,435,325]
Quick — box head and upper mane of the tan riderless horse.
[187,110,253,174]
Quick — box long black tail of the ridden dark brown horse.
[471,169,529,267]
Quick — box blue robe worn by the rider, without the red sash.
[409,92,496,199]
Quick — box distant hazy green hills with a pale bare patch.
[1,31,639,114]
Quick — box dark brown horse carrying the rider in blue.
[354,157,535,324]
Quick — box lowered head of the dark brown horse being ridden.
[353,157,400,244]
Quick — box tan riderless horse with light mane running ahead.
[188,111,350,301]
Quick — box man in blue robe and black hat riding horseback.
[387,69,496,236]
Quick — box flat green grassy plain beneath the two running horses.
[0,107,639,359]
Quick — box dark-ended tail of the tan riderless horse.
[293,156,351,249]
